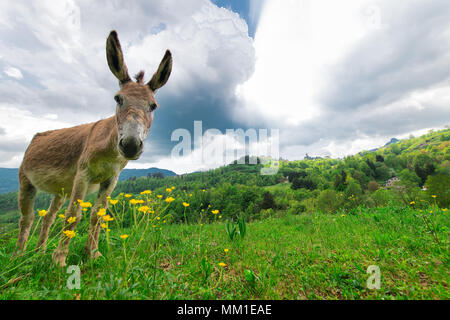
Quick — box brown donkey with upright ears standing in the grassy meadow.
[16,30,172,266]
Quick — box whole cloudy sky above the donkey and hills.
[0,0,450,173]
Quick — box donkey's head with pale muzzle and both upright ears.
[106,31,172,160]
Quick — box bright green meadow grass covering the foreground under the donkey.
[0,207,450,299]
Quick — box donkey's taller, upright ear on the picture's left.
[106,30,131,86]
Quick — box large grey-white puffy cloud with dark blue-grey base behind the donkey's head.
[0,0,254,166]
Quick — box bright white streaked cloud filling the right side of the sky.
[235,0,450,159]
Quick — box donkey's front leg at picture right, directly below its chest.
[85,175,119,258]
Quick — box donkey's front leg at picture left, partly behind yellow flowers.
[52,173,88,267]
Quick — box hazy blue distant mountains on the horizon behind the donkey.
[0,168,176,194]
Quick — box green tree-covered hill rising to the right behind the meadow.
[0,129,450,222]
